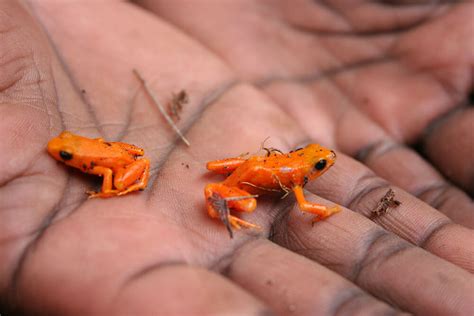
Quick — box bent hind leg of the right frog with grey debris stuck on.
[204,183,260,237]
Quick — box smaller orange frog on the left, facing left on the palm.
[48,131,150,198]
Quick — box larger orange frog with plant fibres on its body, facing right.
[204,144,340,237]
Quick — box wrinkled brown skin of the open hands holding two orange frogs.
[0,0,474,315]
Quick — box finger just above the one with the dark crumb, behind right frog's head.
[265,82,474,227]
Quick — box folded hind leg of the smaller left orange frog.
[114,158,150,195]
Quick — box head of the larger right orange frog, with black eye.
[303,144,336,180]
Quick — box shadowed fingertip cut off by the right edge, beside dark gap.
[424,108,474,196]
